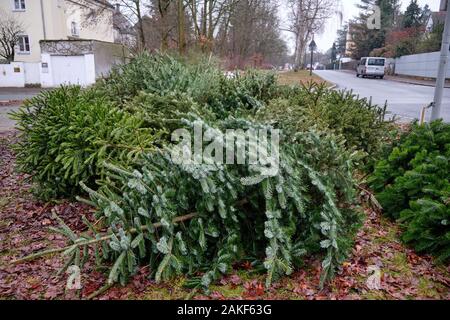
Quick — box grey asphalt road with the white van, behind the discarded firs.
[315,70,450,122]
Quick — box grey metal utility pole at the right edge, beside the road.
[431,0,450,121]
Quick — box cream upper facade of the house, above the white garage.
[0,0,114,62]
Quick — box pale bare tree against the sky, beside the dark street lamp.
[287,0,337,66]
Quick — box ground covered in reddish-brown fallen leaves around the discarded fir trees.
[0,133,450,299]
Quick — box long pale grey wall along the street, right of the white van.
[395,52,450,78]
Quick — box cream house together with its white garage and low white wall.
[0,0,127,87]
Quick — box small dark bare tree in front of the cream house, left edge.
[0,13,25,62]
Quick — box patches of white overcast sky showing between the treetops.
[279,0,440,52]
